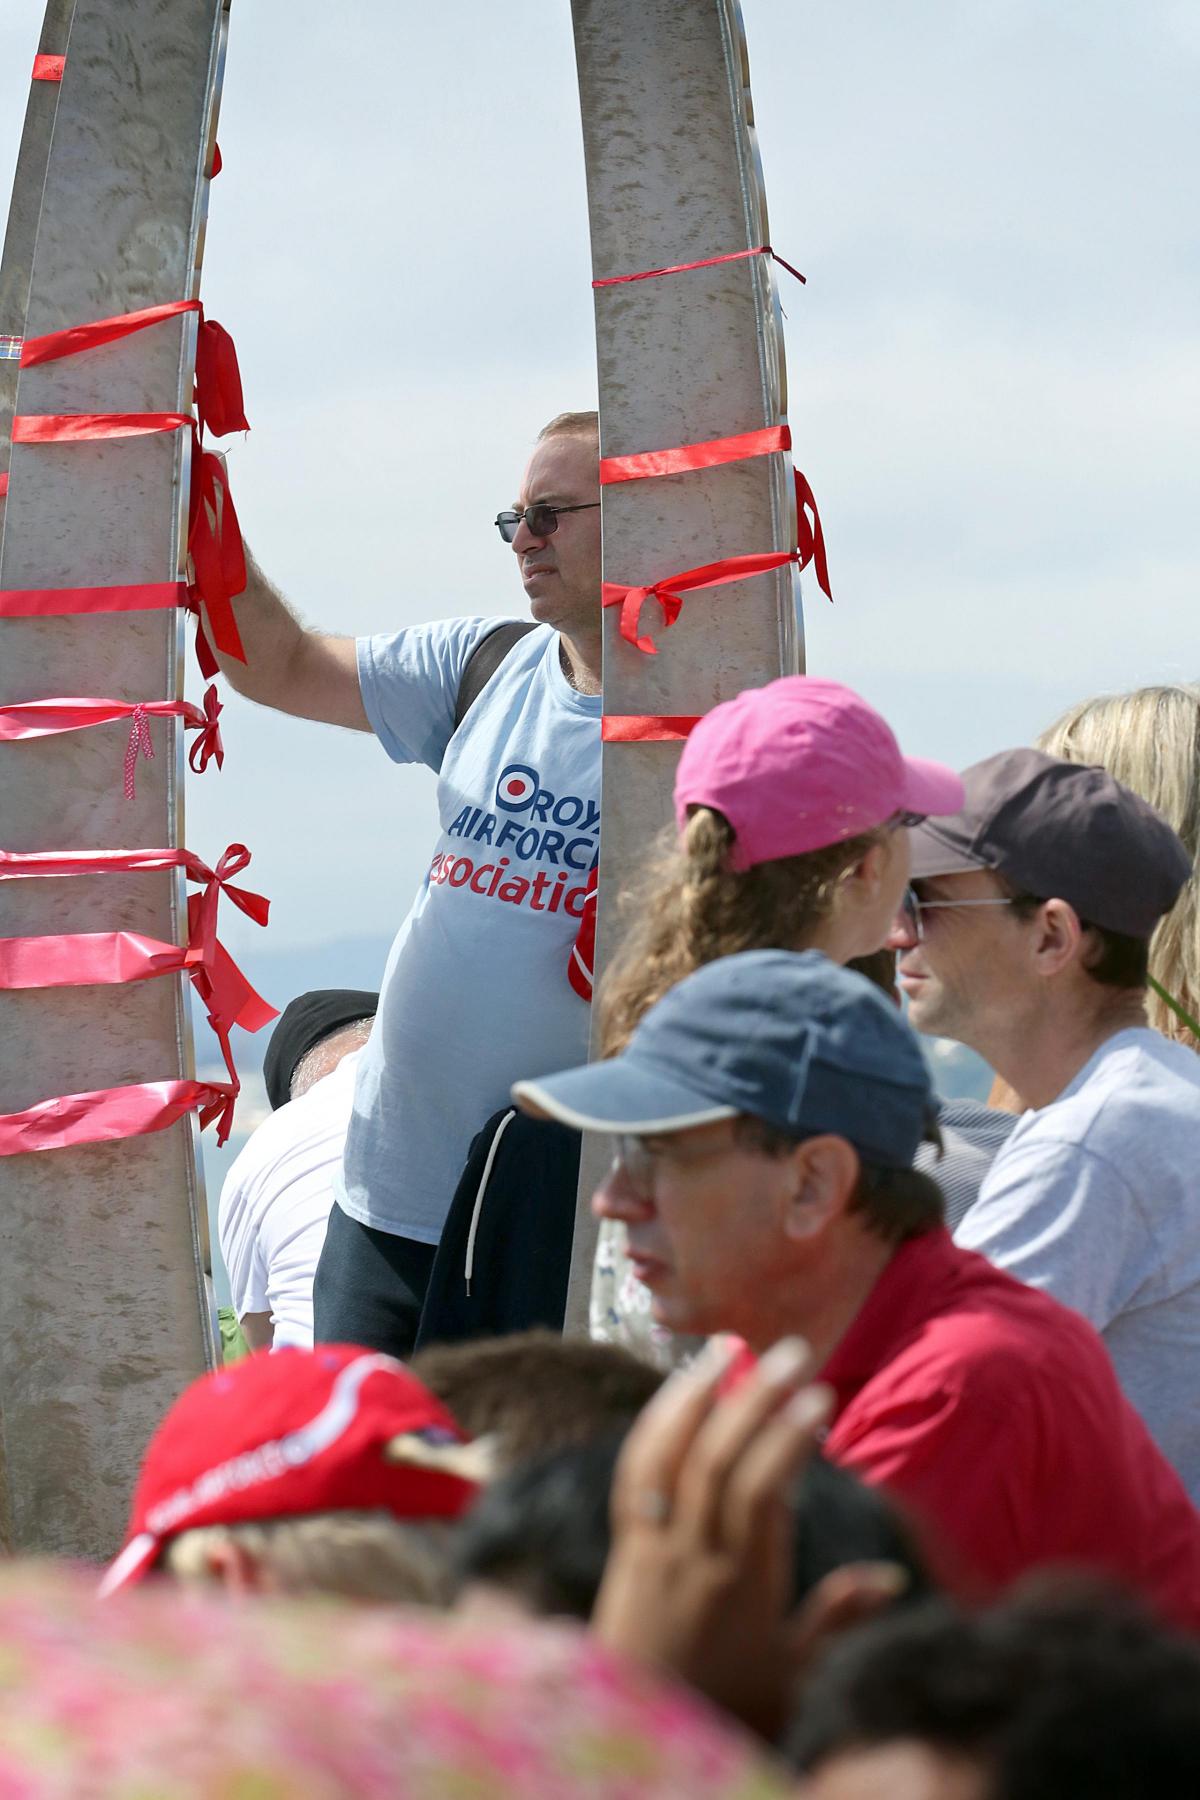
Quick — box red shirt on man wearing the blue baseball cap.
[734,1229,1200,1631]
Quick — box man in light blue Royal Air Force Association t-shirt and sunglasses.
[204,412,601,1355]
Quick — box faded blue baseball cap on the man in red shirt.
[513,950,937,1168]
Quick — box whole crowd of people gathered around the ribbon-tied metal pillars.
[0,414,1200,1800]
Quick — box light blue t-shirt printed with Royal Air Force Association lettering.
[336,619,601,1244]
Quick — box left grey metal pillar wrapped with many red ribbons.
[0,0,228,1557]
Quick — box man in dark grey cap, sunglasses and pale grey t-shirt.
[891,749,1200,1498]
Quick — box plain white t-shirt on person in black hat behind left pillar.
[218,1049,362,1350]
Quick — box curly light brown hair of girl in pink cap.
[599,806,885,1057]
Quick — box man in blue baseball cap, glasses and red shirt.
[513,950,1200,1629]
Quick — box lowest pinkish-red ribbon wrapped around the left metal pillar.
[0,1082,239,1156]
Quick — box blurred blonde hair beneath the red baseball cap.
[162,1512,453,1606]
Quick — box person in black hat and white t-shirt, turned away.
[218,988,380,1350]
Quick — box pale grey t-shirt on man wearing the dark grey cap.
[955,1026,1200,1501]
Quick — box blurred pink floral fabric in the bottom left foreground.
[0,1562,792,1800]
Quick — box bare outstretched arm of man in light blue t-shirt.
[207,551,371,731]
